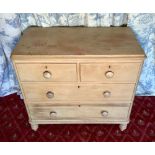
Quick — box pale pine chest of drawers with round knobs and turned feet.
[12,27,145,130]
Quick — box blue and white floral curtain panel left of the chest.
[0,14,21,96]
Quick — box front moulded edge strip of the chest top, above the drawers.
[11,54,143,64]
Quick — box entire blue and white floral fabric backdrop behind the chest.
[0,13,155,96]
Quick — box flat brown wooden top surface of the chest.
[12,27,144,57]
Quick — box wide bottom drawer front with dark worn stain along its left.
[30,105,129,120]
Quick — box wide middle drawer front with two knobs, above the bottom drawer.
[22,82,134,103]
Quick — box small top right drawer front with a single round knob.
[80,63,140,83]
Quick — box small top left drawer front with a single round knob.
[16,64,77,81]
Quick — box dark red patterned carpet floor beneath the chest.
[0,94,155,142]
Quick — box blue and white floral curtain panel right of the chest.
[128,13,155,96]
